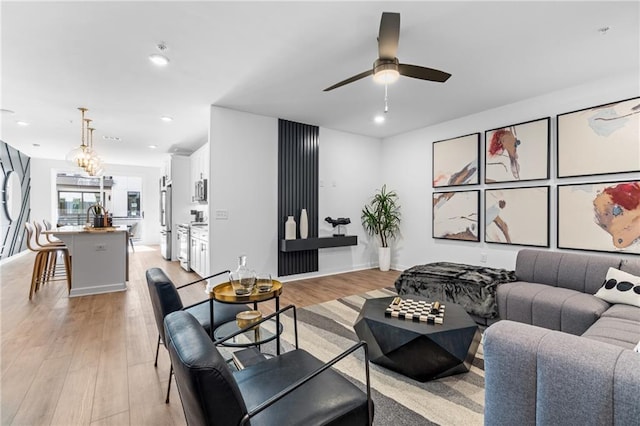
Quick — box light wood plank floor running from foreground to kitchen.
[0,247,399,426]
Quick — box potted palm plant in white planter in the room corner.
[360,185,400,271]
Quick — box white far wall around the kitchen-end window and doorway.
[31,158,161,244]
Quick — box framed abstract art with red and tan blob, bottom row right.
[558,180,640,254]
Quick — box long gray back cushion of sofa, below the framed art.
[516,249,620,294]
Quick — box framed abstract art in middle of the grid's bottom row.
[484,186,549,247]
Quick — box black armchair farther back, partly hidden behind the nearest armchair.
[146,268,247,403]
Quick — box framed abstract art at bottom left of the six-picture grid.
[431,190,480,242]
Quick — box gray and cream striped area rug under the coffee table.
[274,290,484,426]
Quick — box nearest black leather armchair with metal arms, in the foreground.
[165,306,373,426]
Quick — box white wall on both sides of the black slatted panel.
[209,106,381,280]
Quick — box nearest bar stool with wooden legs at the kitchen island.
[24,222,71,300]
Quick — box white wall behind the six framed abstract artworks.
[382,70,640,270]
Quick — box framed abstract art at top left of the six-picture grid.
[431,133,480,188]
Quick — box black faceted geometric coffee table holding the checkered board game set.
[353,296,480,382]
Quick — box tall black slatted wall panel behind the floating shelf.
[278,120,319,276]
